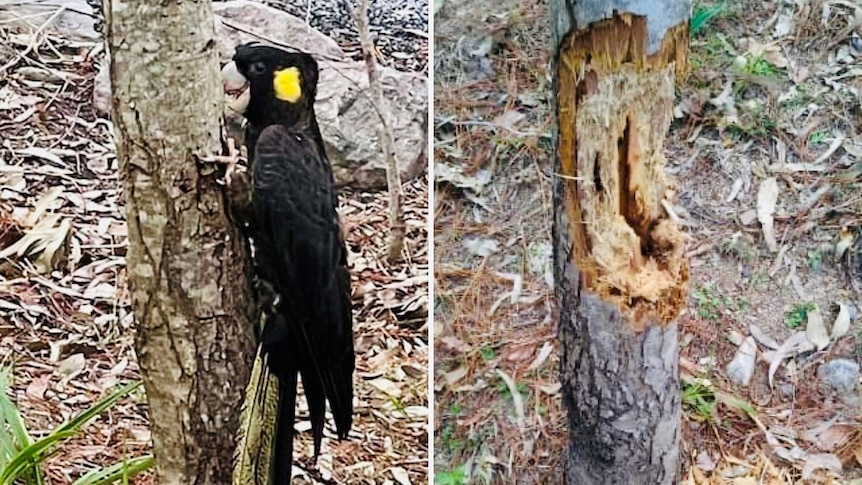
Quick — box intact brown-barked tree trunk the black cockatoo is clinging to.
[105,0,255,485]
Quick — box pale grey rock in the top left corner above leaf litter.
[0,0,102,42]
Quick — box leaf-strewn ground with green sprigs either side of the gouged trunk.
[434,0,862,485]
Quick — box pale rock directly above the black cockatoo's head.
[213,0,344,61]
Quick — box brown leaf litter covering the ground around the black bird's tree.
[0,0,429,485]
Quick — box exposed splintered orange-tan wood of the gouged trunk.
[558,14,688,328]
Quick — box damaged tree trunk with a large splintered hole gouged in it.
[551,0,691,485]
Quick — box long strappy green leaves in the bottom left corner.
[0,368,153,485]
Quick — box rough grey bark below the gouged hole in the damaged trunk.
[554,260,681,485]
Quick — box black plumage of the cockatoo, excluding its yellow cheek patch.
[234,44,354,483]
